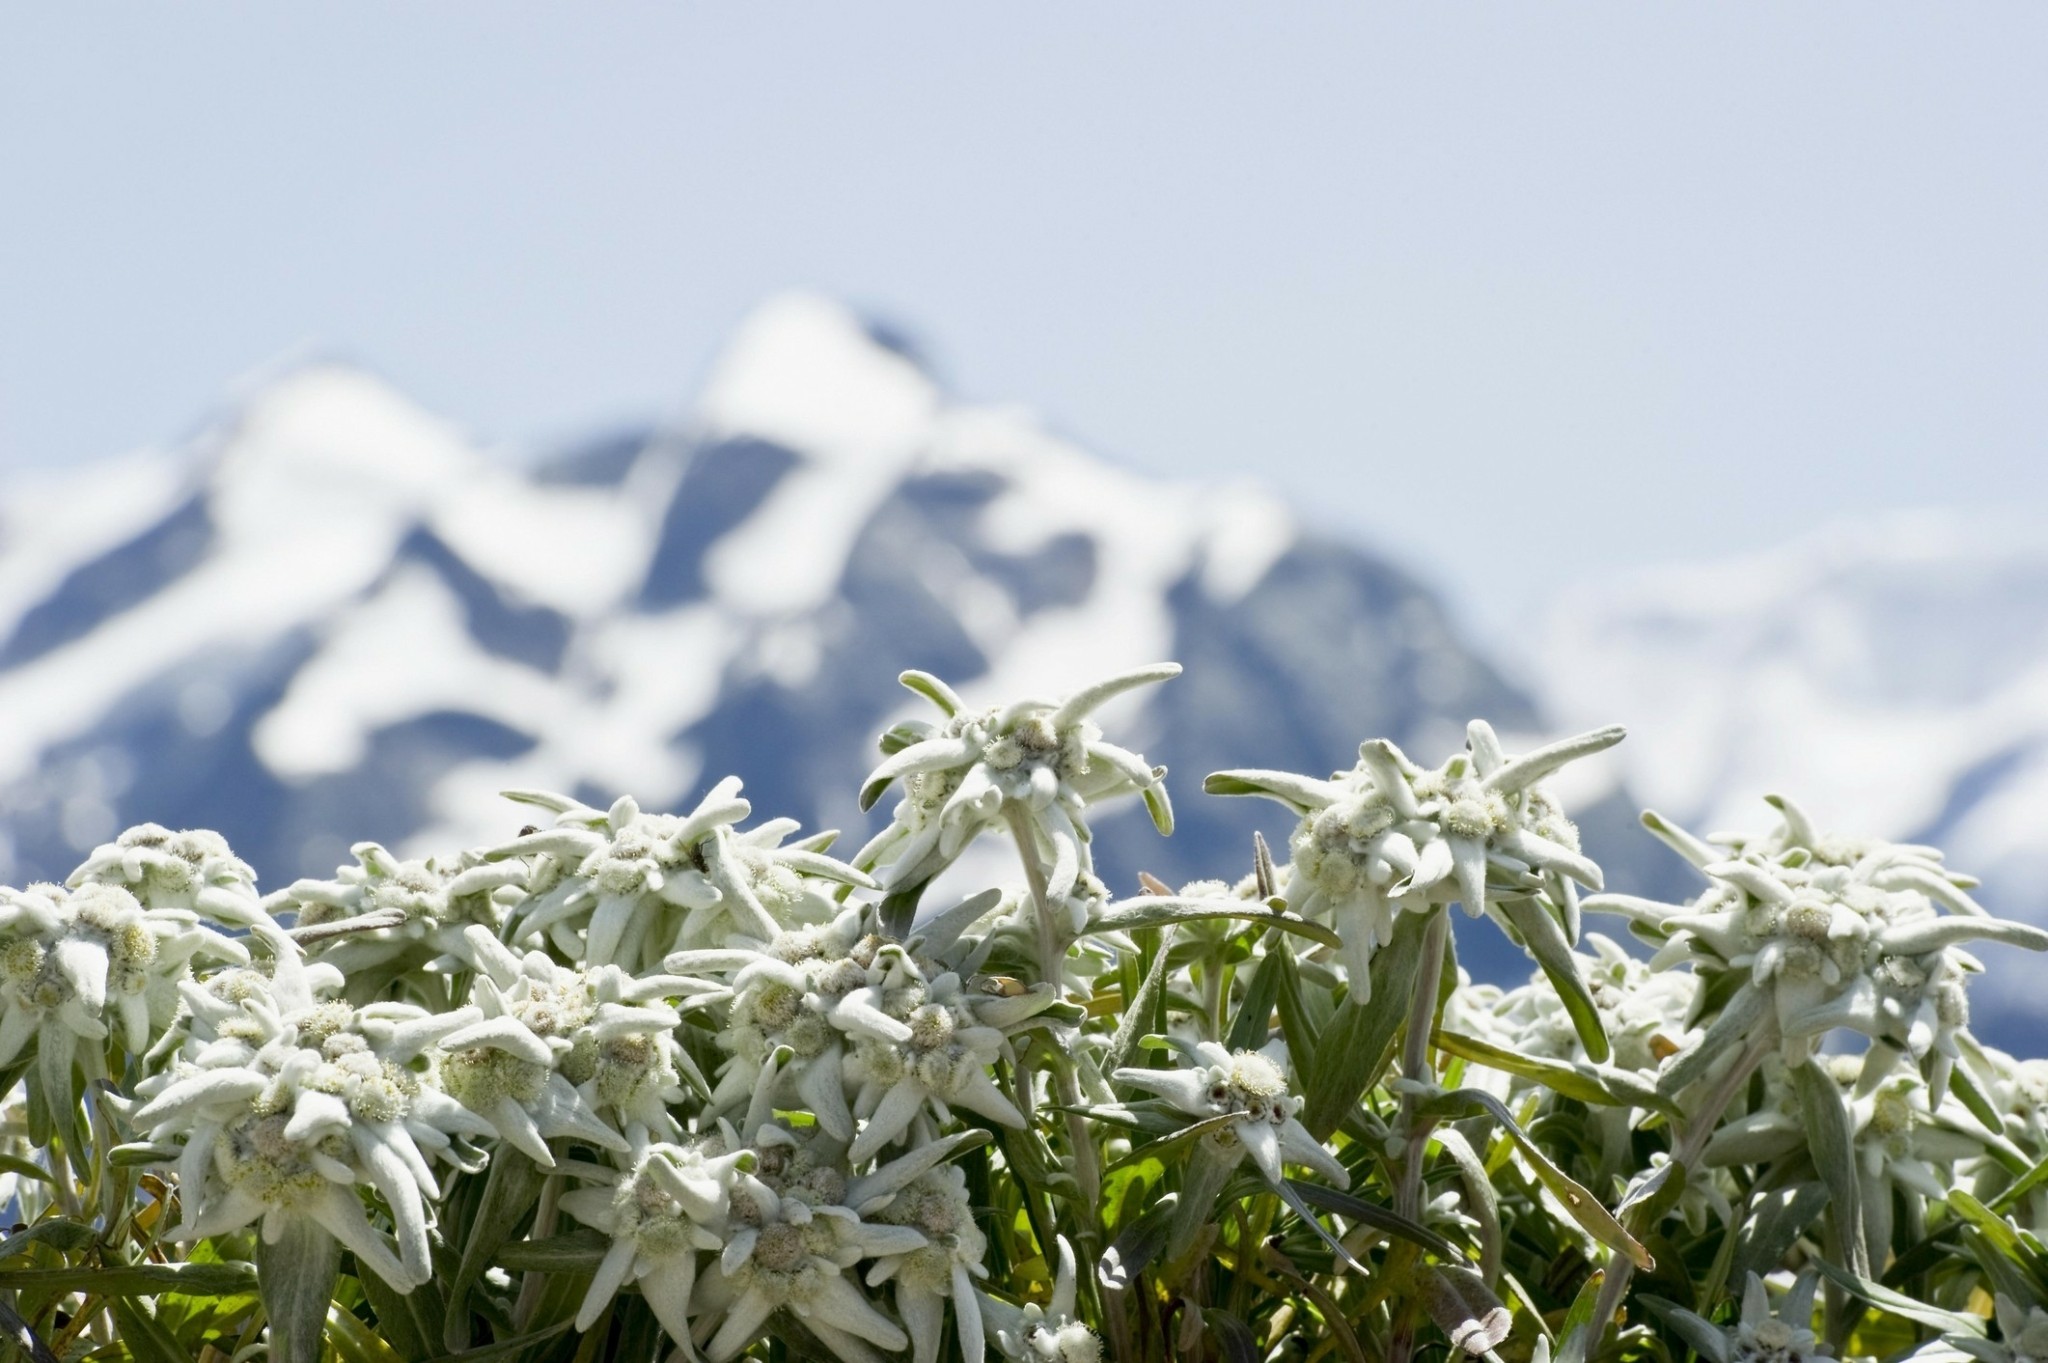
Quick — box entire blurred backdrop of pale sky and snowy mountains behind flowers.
[0,0,2048,1031]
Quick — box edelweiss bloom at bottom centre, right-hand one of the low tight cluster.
[868,1164,989,1363]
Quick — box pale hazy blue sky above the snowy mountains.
[0,0,2048,638]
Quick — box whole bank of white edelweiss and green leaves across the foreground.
[0,663,2048,1363]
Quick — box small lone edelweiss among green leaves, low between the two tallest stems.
[1114,1042,1352,1187]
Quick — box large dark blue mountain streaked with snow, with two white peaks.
[0,297,1622,972]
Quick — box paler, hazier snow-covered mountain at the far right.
[1542,512,2048,1015]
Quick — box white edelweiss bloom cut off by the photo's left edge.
[0,880,248,1111]
